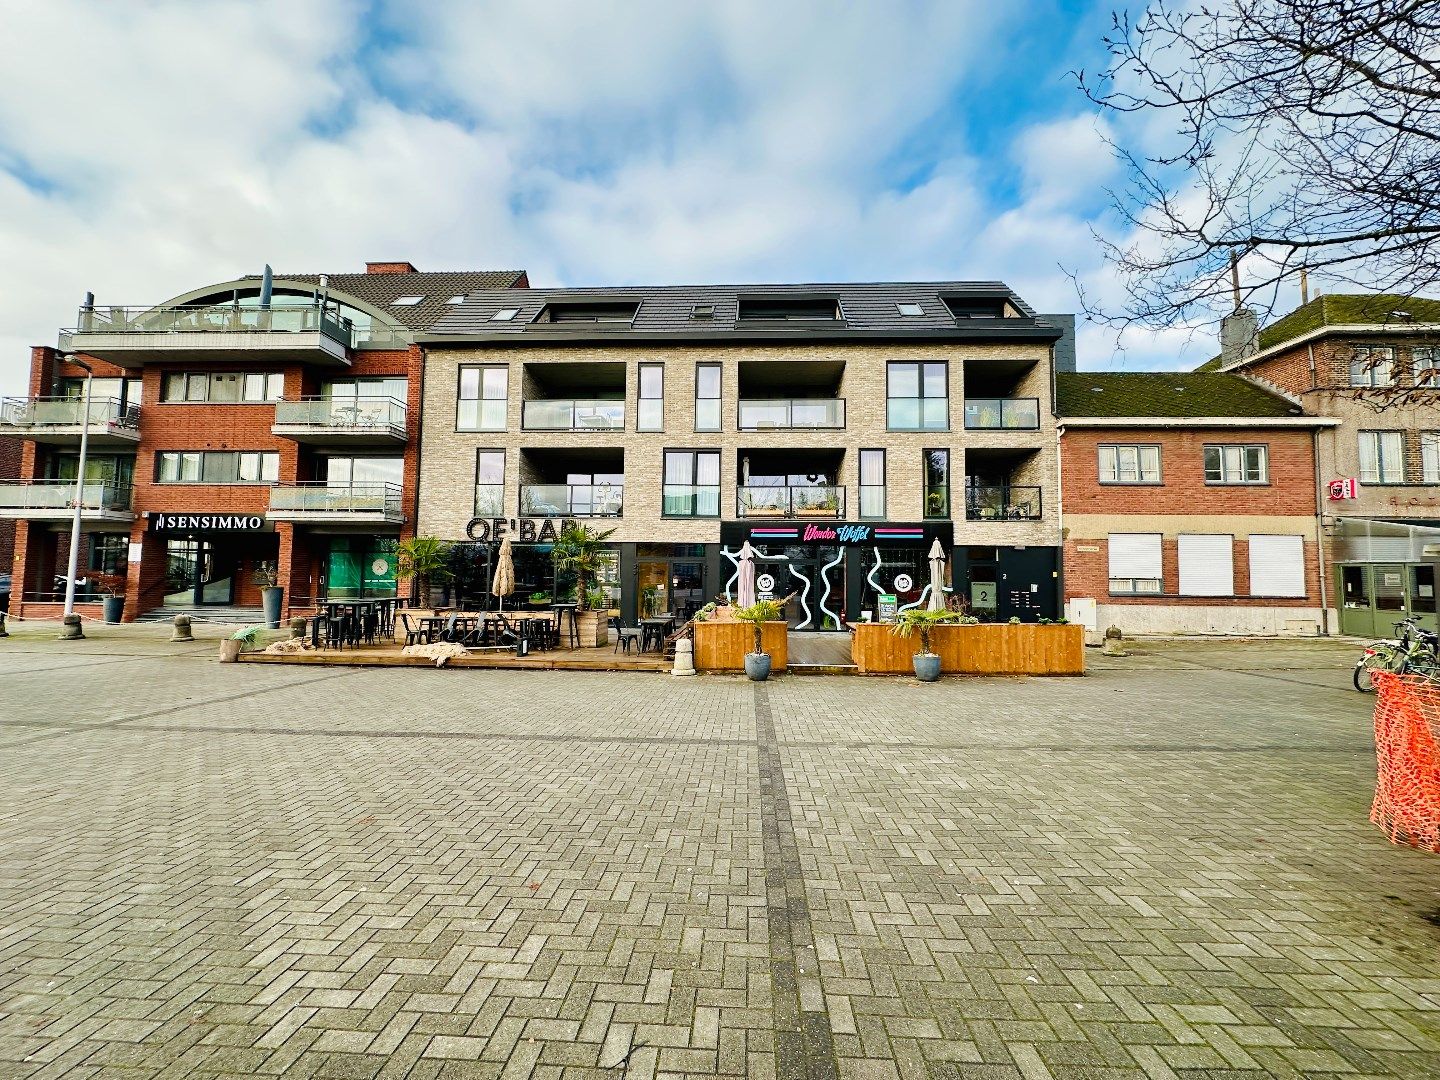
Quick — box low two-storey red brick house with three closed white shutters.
[1056,372,1333,634]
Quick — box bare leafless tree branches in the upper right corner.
[1076,0,1440,328]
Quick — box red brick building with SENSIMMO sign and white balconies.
[0,262,528,619]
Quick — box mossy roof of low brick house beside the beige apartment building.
[1056,372,1300,416]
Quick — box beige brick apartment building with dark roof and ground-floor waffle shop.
[418,282,1066,629]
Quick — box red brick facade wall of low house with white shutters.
[1061,428,1319,608]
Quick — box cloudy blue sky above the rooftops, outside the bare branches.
[0,0,1211,393]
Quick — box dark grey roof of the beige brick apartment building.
[425,281,1061,344]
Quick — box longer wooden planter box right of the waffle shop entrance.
[850,622,1084,675]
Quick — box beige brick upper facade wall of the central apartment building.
[418,344,1060,544]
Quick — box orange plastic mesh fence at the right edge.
[1369,671,1440,852]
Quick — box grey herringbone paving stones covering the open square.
[0,628,1440,1080]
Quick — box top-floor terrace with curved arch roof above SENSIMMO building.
[60,279,410,367]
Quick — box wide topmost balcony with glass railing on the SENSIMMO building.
[60,304,356,367]
